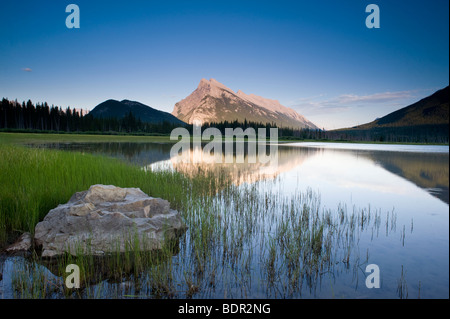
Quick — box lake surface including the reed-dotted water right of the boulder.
[12,143,449,298]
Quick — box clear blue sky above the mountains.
[0,0,449,129]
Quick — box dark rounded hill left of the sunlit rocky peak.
[89,100,186,125]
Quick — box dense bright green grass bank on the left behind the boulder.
[0,143,227,247]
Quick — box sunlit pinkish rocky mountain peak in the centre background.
[172,79,317,129]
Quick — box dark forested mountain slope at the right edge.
[354,86,449,129]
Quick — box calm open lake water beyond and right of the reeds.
[3,143,449,298]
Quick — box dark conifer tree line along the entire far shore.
[0,98,449,143]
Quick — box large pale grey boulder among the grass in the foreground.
[34,185,187,257]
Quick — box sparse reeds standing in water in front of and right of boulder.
[7,180,398,299]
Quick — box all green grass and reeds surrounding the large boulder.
[0,144,403,298]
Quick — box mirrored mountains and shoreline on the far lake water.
[34,143,449,204]
